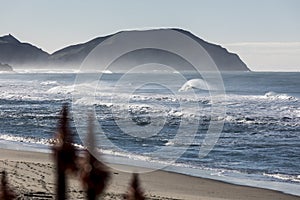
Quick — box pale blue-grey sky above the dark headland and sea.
[0,0,300,71]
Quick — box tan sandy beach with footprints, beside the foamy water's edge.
[0,149,300,200]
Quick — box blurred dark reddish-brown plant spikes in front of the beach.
[0,104,146,200]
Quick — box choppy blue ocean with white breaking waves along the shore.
[0,72,300,195]
